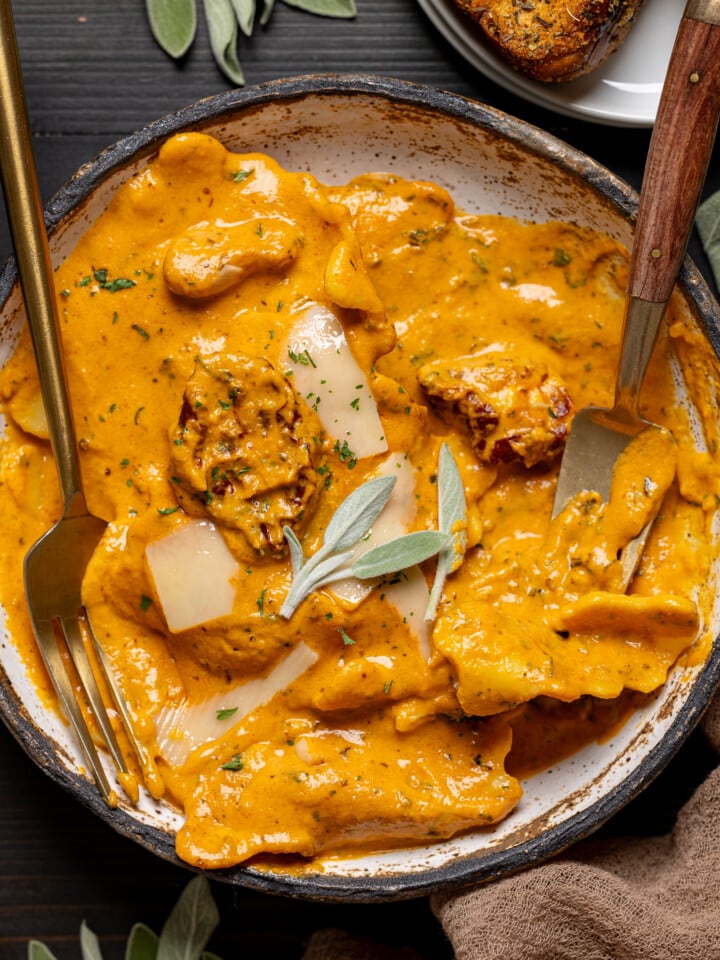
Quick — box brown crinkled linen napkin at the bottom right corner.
[303,694,720,960]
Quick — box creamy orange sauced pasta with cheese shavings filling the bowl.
[0,133,720,868]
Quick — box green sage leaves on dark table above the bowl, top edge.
[145,0,357,86]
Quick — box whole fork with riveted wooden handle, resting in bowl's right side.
[553,0,720,586]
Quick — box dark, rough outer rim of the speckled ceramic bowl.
[0,74,720,903]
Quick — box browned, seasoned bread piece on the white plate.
[451,0,644,83]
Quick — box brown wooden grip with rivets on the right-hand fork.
[628,0,720,303]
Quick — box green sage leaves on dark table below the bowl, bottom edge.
[28,876,220,960]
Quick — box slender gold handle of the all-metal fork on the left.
[0,0,84,513]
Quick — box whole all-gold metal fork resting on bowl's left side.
[0,0,144,806]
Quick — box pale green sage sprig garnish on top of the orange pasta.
[280,444,466,620]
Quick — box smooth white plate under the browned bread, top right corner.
[418,0,685,127]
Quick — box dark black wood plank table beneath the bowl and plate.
[0,0,720,960]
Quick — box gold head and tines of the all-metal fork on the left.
[24,501,139,807]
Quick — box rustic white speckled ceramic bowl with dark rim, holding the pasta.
[0,76,720,901]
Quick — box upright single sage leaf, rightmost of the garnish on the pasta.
[425,443,467,621]
